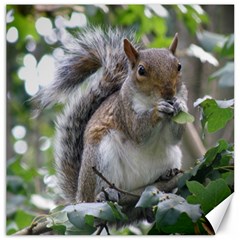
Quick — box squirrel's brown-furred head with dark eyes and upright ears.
[124,33,181,99]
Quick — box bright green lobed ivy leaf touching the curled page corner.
[187,179,231,214]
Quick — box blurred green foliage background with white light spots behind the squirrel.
[6,4,234,234]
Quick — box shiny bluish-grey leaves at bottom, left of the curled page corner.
[136,187,202,234]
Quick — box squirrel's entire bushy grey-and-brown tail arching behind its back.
[33,28,141,202]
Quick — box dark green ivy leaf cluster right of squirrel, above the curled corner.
[178,140,234,206]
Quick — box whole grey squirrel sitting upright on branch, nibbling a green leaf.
[33,27,187,214]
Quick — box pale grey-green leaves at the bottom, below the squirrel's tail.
[47,202,127,235]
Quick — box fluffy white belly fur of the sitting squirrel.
[99,124,182,191]
